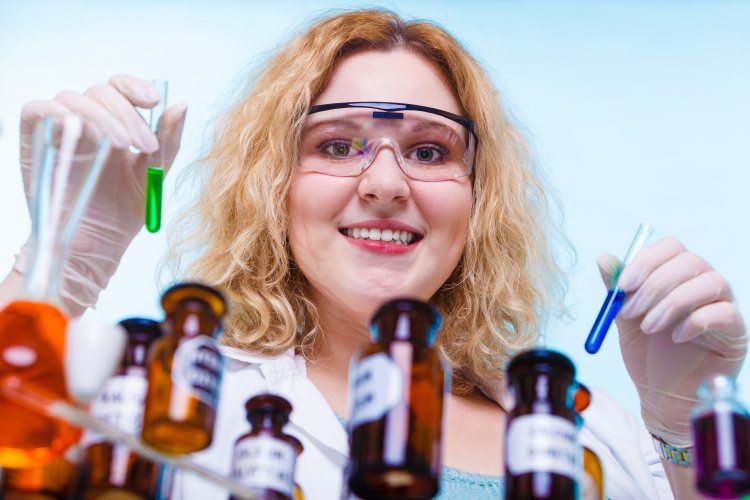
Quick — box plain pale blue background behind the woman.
[0,0,750,422]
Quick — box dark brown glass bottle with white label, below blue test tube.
[505,349,581,500]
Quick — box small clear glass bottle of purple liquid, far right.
[691,375,750,498]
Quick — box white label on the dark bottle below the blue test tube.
[506,415,581,480]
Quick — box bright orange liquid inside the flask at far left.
[0,300,81,468]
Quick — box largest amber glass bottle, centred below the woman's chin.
[348,299,448,498]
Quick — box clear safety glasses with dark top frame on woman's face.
[299,102,477,182]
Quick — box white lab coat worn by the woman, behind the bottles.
[172,347,673,500]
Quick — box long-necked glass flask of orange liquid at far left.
[0,116,108,468]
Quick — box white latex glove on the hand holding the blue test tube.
[598,238,748,447]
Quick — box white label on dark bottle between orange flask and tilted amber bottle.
[82,375,148,446]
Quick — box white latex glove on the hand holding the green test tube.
[13,75,187,316]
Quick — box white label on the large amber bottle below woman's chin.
[350,353,403,427]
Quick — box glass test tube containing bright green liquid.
[146,80,167,233]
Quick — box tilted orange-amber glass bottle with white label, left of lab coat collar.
[141,283,226,453]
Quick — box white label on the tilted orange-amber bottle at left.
[172,335,222,409]
